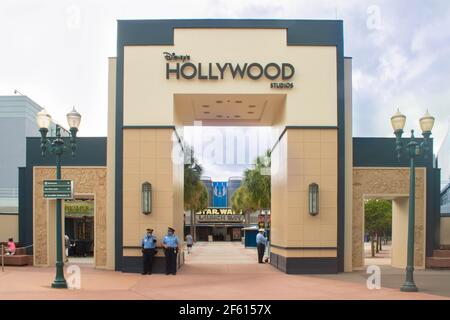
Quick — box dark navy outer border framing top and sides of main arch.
[115,19,345,271]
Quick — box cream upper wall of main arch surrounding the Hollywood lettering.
[123,29,337,126]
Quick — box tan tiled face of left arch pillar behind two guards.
[123,129,183,256]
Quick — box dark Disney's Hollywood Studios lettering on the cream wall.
[164,52,295,88]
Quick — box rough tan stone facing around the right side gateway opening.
[352,168,426,269]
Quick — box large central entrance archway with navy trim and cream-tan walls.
[114,20,351,273]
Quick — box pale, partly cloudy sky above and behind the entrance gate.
[0,0,450,180]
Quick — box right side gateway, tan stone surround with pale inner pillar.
[352,168,426,270]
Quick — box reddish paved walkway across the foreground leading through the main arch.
[0,243,450,300]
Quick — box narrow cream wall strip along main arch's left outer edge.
[105,58,117,270]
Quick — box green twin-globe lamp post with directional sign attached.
[36,108,81,288]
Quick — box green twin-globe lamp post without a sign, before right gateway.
[391,110,434,292]
